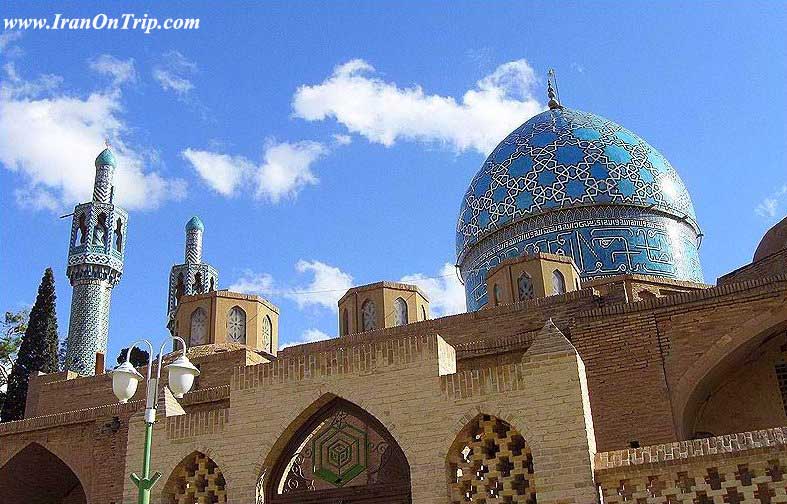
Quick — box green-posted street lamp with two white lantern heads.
[110,336,199,504]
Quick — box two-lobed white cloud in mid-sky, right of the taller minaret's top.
[181,141,328,203]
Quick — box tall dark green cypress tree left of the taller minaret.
[0,268,58,422]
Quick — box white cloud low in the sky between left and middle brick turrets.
[283,259,353,312]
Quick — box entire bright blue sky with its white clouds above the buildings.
[0,1,787,362]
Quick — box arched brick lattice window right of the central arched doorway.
[446,413,536,504]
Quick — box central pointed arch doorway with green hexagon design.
[265,399,412,504]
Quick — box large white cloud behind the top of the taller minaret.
[0,64,185,210]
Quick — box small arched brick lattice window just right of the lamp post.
[161,451,227,504]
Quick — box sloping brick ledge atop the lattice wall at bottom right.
[595,427,787,472]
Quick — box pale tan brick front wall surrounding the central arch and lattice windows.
[124,335,596,504]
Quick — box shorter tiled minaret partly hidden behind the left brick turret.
[167,216,219,331]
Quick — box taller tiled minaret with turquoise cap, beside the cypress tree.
[66,145,128,375]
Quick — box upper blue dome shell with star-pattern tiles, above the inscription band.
[456,108,696,258]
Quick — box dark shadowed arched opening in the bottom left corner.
[0,443,87,504]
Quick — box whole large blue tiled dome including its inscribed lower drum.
[456,103,702,309]
